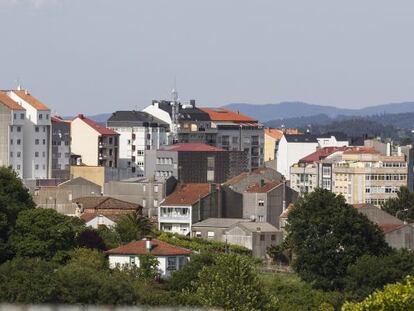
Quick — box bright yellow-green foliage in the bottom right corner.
[342,276,414,311]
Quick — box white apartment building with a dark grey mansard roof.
[107,111,169,177]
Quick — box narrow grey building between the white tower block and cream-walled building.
[52,116,72,179]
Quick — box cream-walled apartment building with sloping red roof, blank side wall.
[70,114,119,168]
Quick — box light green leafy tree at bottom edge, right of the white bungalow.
[195,255,278,311]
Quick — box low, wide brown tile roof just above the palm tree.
[73,196,142,211]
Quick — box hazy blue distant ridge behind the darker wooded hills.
[225,102,414,122]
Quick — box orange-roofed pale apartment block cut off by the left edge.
[0,91,26,177]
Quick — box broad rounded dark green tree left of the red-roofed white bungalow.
[9,208,85,259]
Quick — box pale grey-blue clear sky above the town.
[0,0,414,115]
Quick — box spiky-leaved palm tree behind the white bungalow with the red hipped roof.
[115,212,153,243]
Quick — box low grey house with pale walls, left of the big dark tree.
[224,222,283,258]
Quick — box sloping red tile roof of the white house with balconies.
[161,184,210,206]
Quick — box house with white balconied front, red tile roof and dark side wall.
[158,183,219,235]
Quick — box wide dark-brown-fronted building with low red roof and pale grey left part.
[146,143,247,183]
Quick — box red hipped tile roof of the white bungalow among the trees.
[105,239,192,256]
